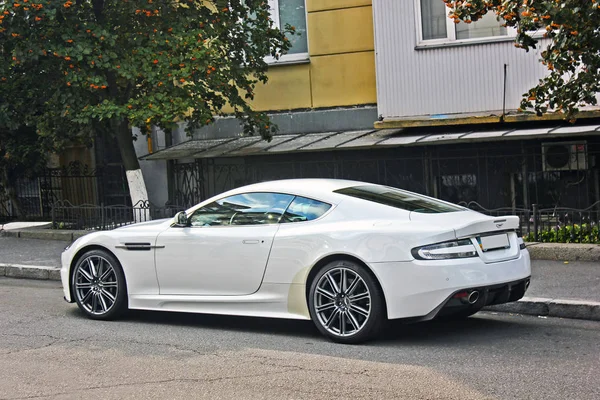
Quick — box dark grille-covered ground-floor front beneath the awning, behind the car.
[171,137,600,213]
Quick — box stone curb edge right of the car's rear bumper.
[484,297,600,321]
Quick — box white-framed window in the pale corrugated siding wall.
[416,0,513,45]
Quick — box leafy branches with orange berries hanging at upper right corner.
[443,0,600,118]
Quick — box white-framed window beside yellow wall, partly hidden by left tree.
[267,0,308,63]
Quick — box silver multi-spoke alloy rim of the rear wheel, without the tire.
[314,267,371,337]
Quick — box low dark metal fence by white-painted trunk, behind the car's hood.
[52,200,185,230]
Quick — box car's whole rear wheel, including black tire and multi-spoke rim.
[308,260,385,343]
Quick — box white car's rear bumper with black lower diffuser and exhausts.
[370,250,531,319]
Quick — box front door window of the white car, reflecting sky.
[190,193,294,226]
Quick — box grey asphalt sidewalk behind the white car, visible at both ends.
[0,237,600,302]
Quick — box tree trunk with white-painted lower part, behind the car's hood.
[114,120,149,222]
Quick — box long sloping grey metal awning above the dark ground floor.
[140,125,600,160]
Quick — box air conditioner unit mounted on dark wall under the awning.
[542,141,588,171]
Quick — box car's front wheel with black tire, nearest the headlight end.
[71,250,127,320]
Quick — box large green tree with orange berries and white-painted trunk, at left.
[0,0,293,203]
